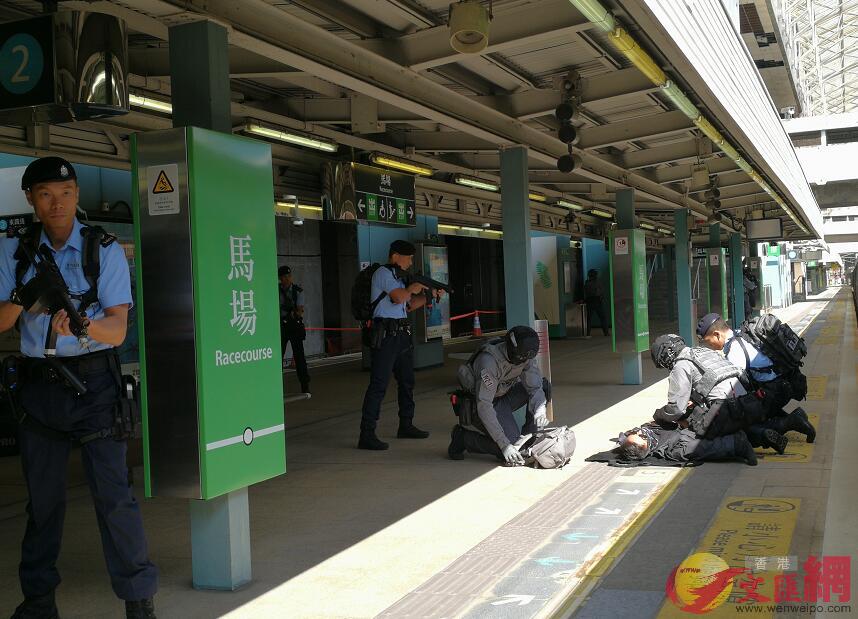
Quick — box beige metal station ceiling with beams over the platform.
[0,0,820,238]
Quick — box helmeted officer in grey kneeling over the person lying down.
[650,336,807,453]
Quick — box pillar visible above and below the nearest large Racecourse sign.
[169,21,251,591]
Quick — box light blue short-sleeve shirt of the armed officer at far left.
[0,219,132,357]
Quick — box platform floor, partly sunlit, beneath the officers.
[0,289,858,618]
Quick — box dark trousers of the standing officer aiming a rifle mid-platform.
[360,331,414,431]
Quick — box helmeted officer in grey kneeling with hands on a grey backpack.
[447,326,551,465]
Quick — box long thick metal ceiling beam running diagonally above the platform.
[105,0,708,215]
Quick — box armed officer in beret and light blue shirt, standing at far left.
[0,157,158,619]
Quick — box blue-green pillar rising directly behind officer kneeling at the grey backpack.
[500,146,533,329]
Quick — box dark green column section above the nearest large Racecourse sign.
[170,21,231,132]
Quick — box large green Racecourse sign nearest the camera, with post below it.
[132,127,286,589]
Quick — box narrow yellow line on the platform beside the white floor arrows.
[538,467,691,619]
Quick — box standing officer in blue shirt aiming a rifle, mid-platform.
[358,240,429,450]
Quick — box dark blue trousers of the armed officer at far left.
[19,370,158,600]
